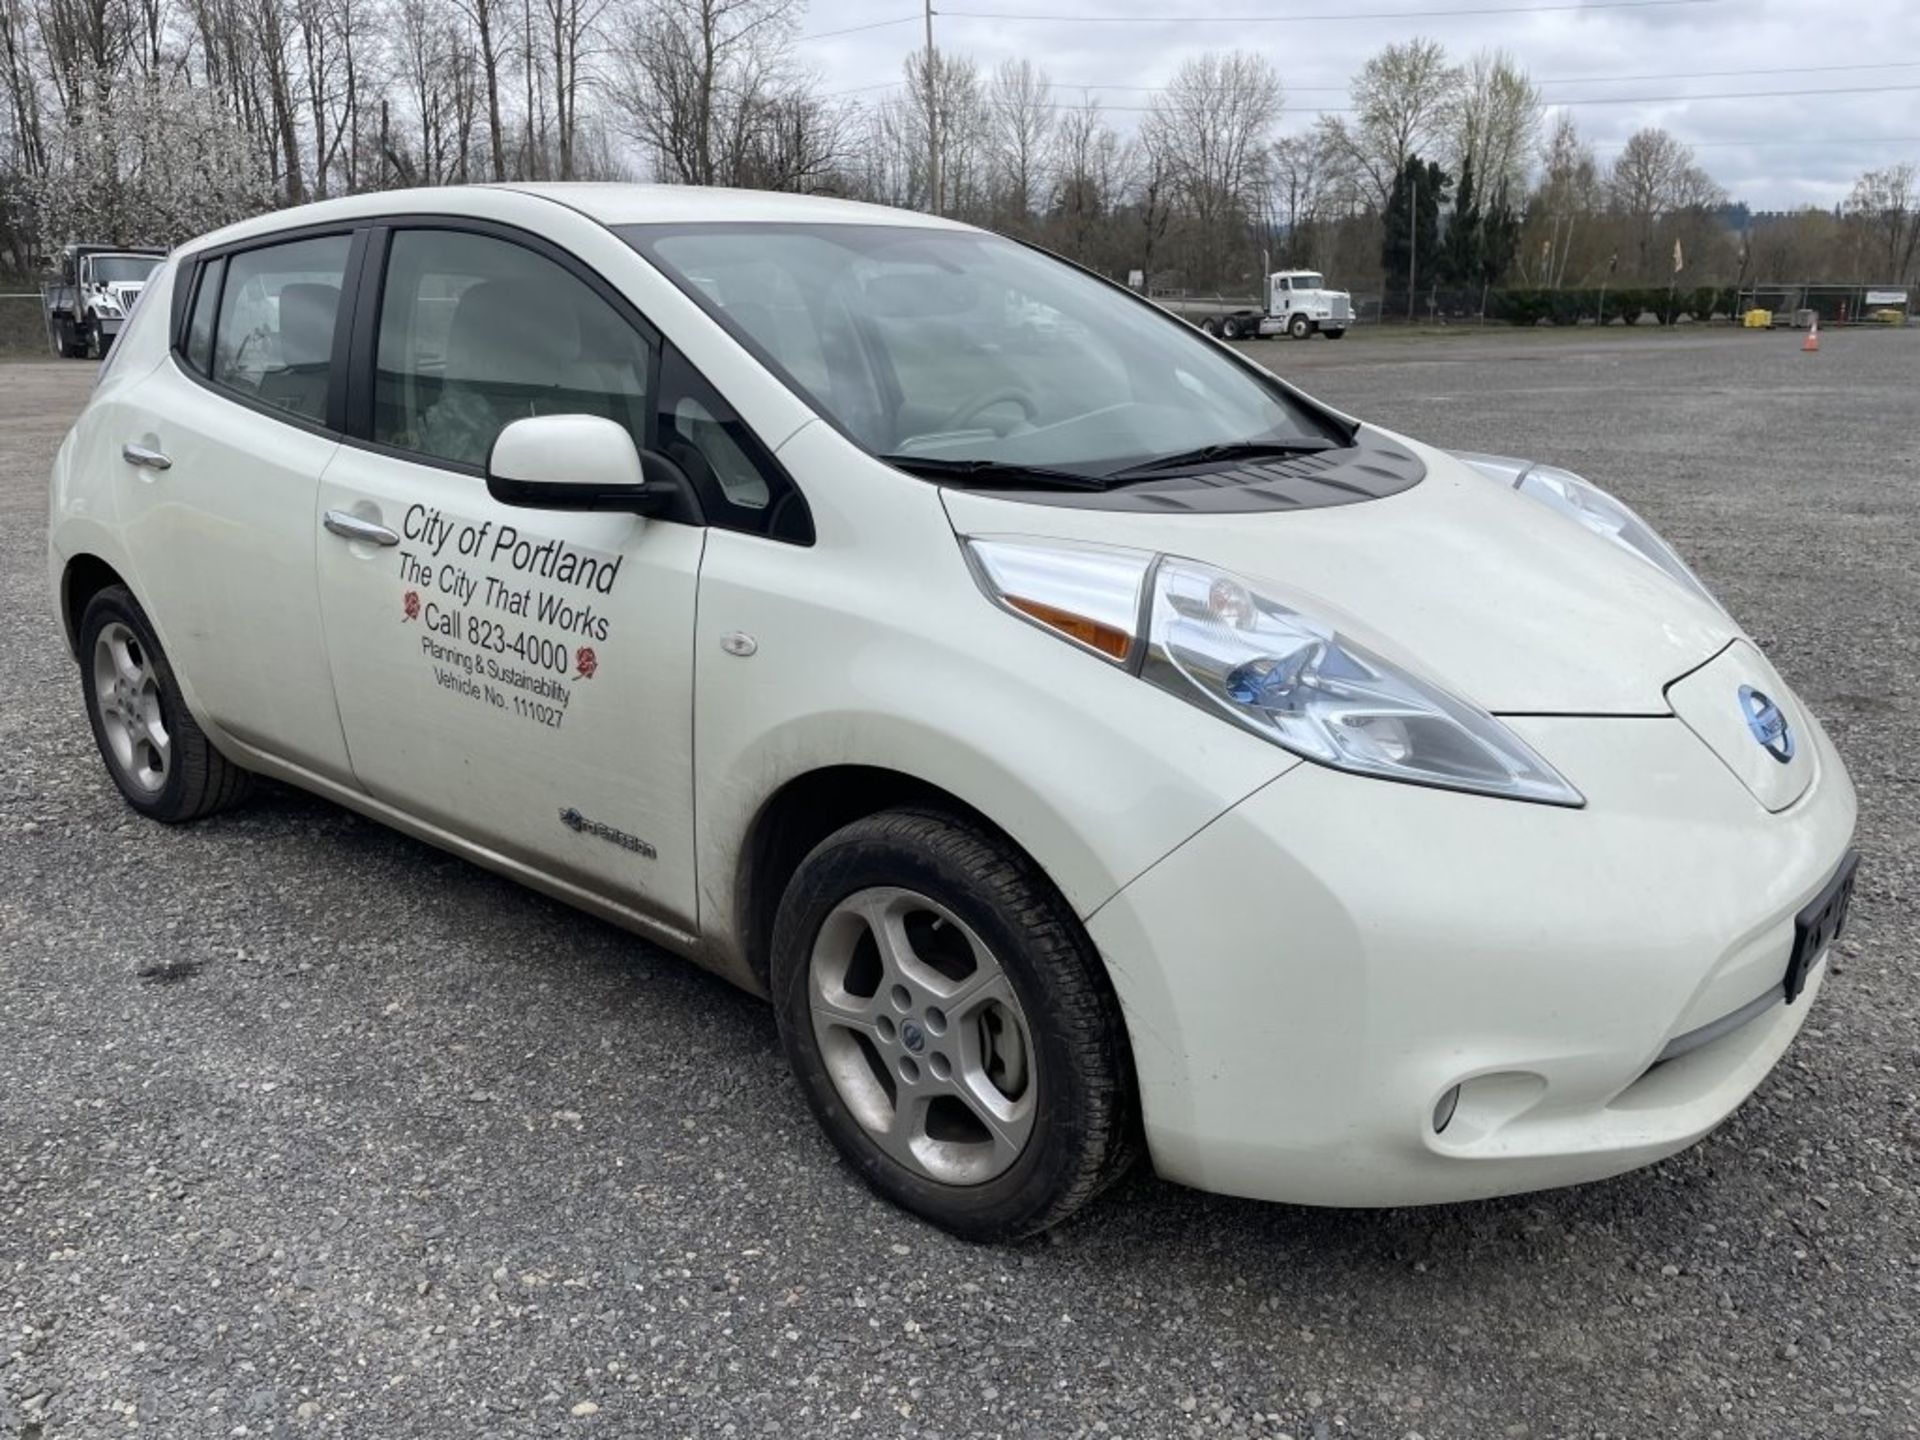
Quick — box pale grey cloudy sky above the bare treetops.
[797,0,1920,209]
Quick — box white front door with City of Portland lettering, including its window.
[317,228,705,931]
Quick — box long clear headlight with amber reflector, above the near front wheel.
[968,540,1586,806]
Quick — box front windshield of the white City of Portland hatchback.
[622,223,1344,474]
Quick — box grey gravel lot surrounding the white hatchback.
[0,332,1920,1440]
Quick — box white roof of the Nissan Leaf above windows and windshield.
[176,180,972,250]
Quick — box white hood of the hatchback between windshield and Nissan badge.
[945,436,1740,714]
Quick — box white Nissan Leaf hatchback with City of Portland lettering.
[50,184,1855,1238]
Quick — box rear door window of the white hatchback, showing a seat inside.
[212,234,353,422]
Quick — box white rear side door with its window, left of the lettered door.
[111,228,357,780]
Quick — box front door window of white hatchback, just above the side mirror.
[372,230,653,465]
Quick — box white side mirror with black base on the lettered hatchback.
[486,415,697,522]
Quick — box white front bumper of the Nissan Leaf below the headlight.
[1091,718,1855,1206]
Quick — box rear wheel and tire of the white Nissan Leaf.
[81,586,253,826]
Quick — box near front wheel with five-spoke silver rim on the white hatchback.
[772,810,1135,1240]
